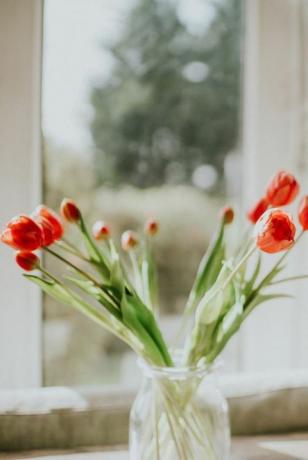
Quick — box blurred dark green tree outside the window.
[91,0,242,187]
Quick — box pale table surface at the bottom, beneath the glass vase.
[0,433,308,460]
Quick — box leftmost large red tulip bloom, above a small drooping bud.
[0,215,43,251]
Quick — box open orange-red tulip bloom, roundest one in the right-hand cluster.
[256,209,296,254]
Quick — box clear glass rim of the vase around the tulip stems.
[138,350,222,380]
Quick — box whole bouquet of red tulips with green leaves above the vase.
[1,171,308,458]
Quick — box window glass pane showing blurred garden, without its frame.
[43,0,242,385]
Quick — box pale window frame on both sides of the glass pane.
[0,0,308,389]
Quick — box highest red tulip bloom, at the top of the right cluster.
[266,171,299,206]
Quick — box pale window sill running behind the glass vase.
[0,371,308,452]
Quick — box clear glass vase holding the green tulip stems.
[129,361,230,460]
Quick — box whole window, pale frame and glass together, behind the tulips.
[0,0,308,388]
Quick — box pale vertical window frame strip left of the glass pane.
[0,0,43,388]
